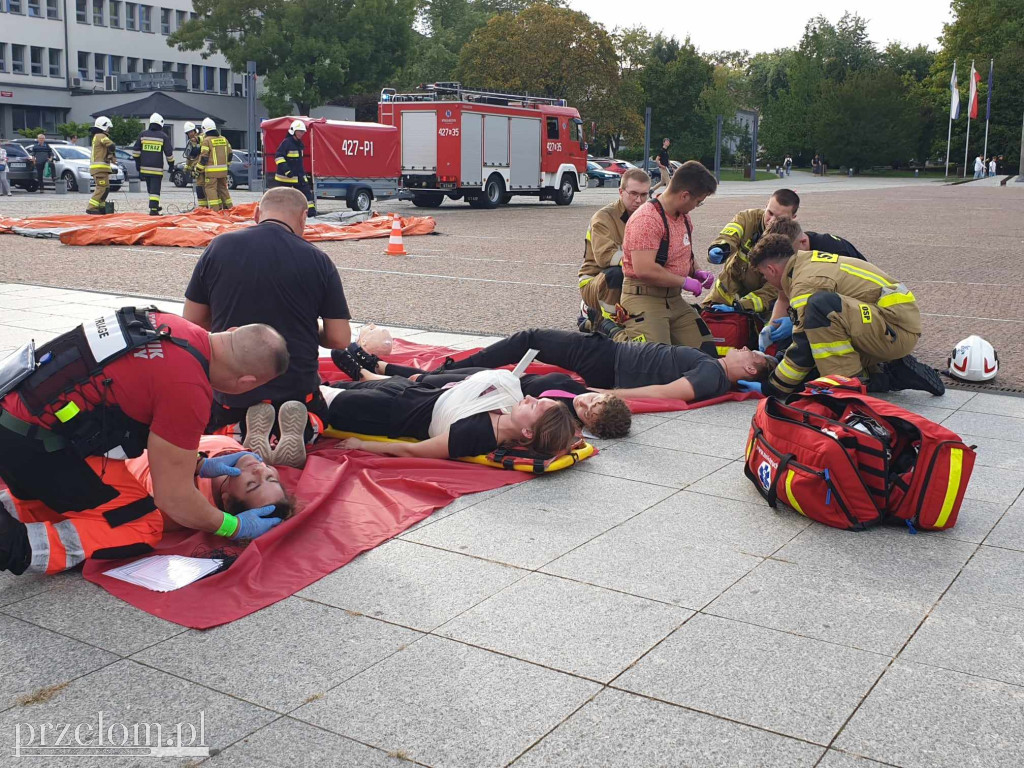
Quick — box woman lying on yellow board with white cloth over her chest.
[321,371,578,459]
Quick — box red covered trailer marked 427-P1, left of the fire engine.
[260,117,401,211]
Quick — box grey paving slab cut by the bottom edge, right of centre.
[515,689,822,768]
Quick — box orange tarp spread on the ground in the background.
[0,203,435,248]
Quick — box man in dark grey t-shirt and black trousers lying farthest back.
[339,328,775,409]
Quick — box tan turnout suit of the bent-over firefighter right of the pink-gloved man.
[703,208,778,313]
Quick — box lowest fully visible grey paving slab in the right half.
[613,614,890,744]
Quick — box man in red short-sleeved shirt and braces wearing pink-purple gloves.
[622,160,718,355]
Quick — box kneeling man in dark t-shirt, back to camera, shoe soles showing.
[183,187,351,464]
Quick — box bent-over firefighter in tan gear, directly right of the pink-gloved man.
[702,189,800,316]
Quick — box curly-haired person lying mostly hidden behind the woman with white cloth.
[361,364,633,439]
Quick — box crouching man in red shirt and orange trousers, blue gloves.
[0,307,288,573]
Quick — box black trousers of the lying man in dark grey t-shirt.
[447,328,617,389]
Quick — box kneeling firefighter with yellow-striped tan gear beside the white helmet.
[746,234,945,396]
